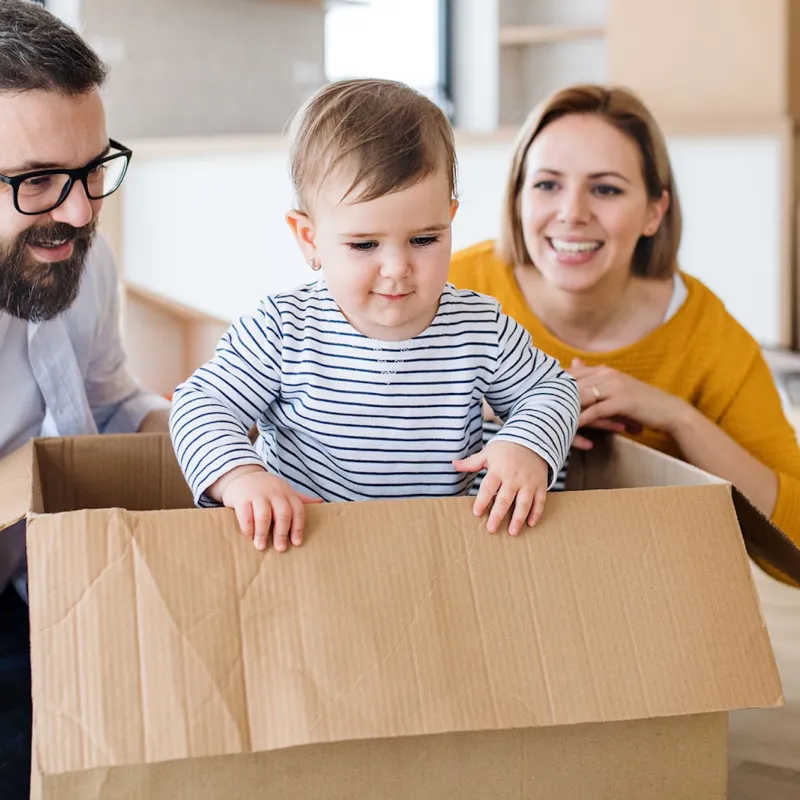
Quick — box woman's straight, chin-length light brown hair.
[497,85,682,278]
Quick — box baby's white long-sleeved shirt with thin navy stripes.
[171,281,579,505]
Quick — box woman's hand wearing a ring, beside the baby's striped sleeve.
[568,358,693,450]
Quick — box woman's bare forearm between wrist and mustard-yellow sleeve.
[669,403,778,517]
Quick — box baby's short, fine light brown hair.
[289,79,457,213]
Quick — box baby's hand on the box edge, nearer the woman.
[453,441,548,536]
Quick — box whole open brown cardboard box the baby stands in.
[0,436,797,800]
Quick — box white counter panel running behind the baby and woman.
[123,135,784,345]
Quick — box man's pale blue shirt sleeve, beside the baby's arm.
[84,237,169,433]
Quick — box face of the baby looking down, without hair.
[313,171,457,341]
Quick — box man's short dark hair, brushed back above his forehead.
[0,0,106,95]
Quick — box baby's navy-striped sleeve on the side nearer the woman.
[486,311,580,487]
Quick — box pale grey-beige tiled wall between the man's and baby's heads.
[83,0,325,138]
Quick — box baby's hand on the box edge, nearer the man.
[208,464,322,553]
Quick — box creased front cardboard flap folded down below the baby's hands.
[28,484,781,774]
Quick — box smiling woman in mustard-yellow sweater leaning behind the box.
[450,86,800,579]
